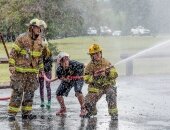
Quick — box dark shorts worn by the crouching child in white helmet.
[56,80,84,97]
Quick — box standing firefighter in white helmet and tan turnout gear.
[8,19,44,121]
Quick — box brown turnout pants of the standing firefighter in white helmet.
[8,74,38,115]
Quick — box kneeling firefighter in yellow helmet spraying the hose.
[84,44,118,120]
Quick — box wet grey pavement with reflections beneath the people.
[0,75,170,130]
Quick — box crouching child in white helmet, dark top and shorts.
[56,52,85,116]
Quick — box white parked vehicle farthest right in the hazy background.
[130,26,151,35]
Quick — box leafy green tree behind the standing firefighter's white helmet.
[0,0,83,38]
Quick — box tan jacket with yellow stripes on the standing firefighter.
[9,32,44,73]
